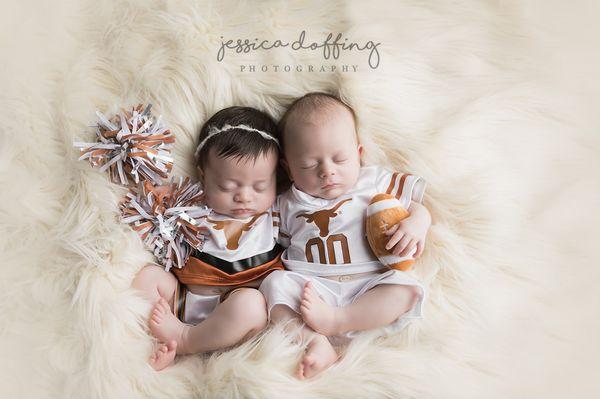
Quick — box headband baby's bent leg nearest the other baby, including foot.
[150,288,267,354]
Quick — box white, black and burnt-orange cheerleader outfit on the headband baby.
[171,208,283,324]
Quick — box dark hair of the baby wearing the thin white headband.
[196,106,279,170]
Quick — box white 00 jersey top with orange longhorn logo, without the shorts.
[278,166,426,276]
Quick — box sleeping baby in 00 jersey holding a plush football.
[260,93,431,379]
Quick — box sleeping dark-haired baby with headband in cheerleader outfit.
[132,107,283,370]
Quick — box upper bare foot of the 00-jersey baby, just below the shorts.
[300,281,343,337]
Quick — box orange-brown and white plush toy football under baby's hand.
[366,194,417,271]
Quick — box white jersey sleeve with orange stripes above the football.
[377,168,427,209]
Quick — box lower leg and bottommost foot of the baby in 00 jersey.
[271,305,339,380]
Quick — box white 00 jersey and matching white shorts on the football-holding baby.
[260,166,426,336]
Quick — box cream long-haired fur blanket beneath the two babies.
[0,0,600,398]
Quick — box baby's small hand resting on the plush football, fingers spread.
[385,212,429,259]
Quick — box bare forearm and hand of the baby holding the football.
[385,201,431,259]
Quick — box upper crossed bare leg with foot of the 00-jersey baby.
[300,282,418,336]
